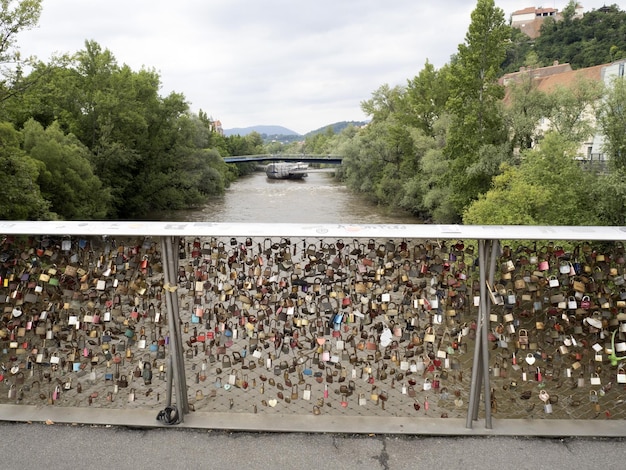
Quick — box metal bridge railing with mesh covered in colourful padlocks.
[0,221,626,433]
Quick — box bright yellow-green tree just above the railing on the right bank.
[463,132,601,225]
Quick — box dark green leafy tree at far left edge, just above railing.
[0,122,52,220]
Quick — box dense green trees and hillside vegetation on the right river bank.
[292,0,626,225]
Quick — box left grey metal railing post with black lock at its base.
[161,236,189,421]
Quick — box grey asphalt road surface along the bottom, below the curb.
[0,422,626,470]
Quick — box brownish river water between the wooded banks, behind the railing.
[158,171,419,224]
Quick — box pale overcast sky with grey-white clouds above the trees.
[17,0,617,134]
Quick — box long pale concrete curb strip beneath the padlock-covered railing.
[0,405,626,437]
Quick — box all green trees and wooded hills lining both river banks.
[0,0,626,225]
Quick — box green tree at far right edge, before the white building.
[598,77,626,170]
